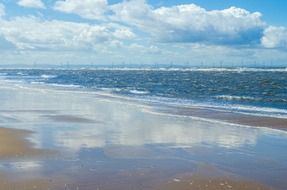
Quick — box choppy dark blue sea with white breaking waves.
[0,67,287,118]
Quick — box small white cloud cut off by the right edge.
[261,26,287,49]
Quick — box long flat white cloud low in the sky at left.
[0,17,135,50]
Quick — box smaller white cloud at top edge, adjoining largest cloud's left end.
[54,0,108,19]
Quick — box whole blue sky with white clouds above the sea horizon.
[0,0,287,66]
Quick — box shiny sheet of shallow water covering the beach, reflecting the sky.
[0,82,287,190]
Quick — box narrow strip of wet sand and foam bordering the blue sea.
[3,78,287,132]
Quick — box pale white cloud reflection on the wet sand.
[53,114,259,149]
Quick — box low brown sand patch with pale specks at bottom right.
[155,164,272,190]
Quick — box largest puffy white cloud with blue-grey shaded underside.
[111,0,265,44]
